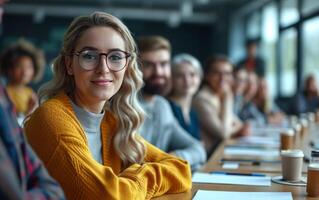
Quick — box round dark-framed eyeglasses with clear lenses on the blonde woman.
[72,50,131,72]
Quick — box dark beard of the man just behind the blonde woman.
[142,77,171,96]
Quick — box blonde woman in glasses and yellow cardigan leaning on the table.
[25,12,191,200]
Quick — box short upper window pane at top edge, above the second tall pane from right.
[280,0,299,26]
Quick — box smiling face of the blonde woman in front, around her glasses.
[67,27,129,110]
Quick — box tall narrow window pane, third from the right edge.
[261,3,278,97]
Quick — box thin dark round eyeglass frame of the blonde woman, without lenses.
[69,49,132,72]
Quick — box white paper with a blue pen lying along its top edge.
[192,172,271,186]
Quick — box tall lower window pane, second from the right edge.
[280,28,297,96]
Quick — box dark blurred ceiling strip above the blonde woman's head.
[5,0,253,25]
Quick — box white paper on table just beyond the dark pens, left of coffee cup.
[224,147,280,157]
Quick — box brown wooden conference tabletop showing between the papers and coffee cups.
[154,120,319,200]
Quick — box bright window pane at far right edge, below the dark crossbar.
[302,17,319,83]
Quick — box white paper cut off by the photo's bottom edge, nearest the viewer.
[193,190,292,200]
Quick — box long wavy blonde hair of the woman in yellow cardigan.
[39,12,145,166]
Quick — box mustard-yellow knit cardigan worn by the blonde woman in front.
[25,94,191,200]
